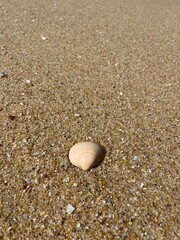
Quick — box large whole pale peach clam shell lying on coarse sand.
[69,142,106,170]
